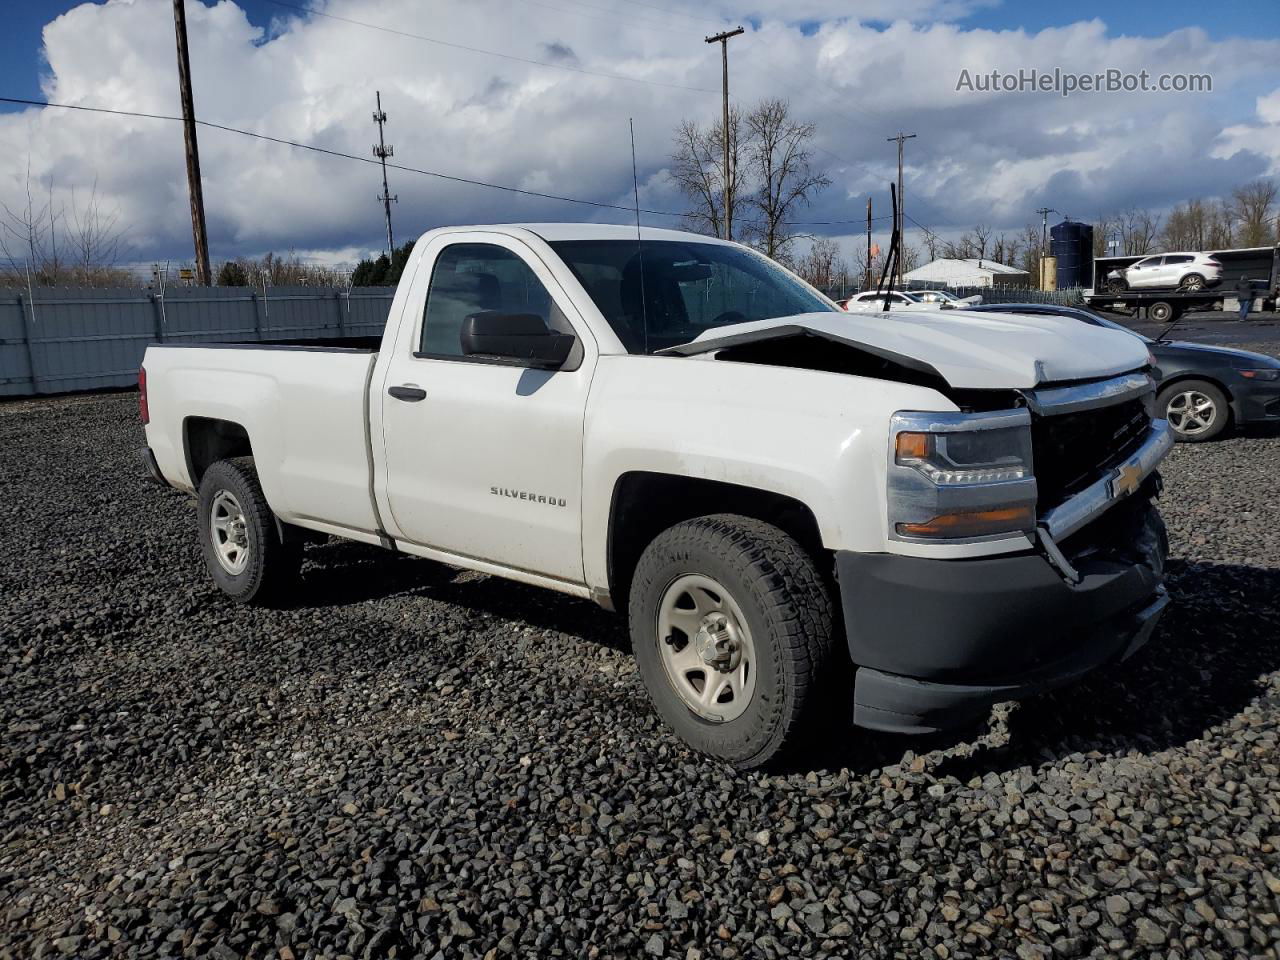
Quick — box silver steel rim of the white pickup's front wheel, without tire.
[658,573,755,723]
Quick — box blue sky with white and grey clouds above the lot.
[0,0,1280,271]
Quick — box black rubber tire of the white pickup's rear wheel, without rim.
[198,457,302,605]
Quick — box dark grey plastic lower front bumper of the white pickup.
[836,497,1167,733]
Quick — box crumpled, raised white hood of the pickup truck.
[663,316,1147,389]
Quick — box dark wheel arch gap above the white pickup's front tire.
[605,471,833,609]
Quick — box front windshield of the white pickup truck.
[550,241,840,353]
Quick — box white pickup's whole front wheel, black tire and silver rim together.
[628,513,836,769]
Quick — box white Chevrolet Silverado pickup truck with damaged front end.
[140,224,1171,767]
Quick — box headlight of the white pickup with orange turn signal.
[888,410,1036,541]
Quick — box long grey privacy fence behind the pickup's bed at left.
[0,287,396,397]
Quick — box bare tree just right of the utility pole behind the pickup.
[742,100,831,259]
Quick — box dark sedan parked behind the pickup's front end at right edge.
[965,303,1280,443]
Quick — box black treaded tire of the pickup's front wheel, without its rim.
[628,513,842,769]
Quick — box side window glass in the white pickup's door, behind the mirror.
[417,243,560,357]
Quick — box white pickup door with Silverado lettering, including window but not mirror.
[380,239,596,584]
